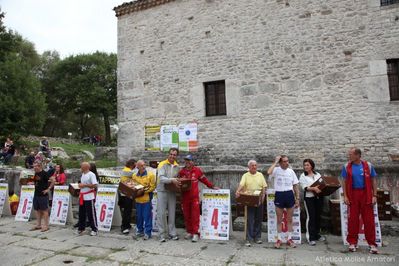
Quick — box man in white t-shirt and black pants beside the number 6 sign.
[78,162,98,236]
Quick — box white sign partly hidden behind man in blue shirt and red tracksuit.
[339,188,382,247]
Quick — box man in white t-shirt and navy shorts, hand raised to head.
[267,155,299,248]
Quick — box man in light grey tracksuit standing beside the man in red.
[157,148,180,242]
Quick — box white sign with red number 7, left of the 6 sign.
[50,186,70,225]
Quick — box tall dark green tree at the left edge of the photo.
[0,8,46,135]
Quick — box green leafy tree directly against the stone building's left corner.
[44,52,116,144]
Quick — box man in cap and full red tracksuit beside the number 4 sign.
[179,154,218,242]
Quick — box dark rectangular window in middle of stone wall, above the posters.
[204,80,226,116]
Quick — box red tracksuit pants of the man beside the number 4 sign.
[181,197,200,235]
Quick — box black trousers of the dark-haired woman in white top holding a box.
[304,197,323,241]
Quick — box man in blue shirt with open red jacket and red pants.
[341,148,378,254]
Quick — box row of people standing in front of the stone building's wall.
[24,148,378,254]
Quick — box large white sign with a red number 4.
[200,189,230,240]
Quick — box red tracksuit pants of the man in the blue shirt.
[346,189,377,246]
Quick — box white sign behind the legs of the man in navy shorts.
[267,189,301,244]
